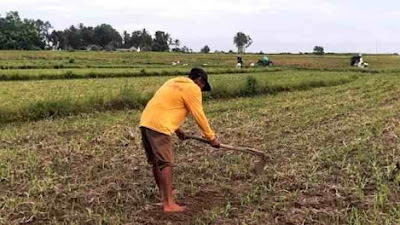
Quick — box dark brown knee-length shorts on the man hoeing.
[140,127,173,170]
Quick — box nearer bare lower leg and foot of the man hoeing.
[159,166,185,212]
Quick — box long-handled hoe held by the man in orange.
[185,135,267,175]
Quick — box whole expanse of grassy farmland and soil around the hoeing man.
[0,51,400,224]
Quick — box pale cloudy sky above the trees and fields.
[0,0,400,53]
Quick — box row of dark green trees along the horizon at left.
[0,11,192,52]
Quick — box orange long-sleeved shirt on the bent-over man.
[140,77,215,140]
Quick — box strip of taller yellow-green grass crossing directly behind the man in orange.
[0,72,357,123]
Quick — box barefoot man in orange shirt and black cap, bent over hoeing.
[140,68,220,212]
